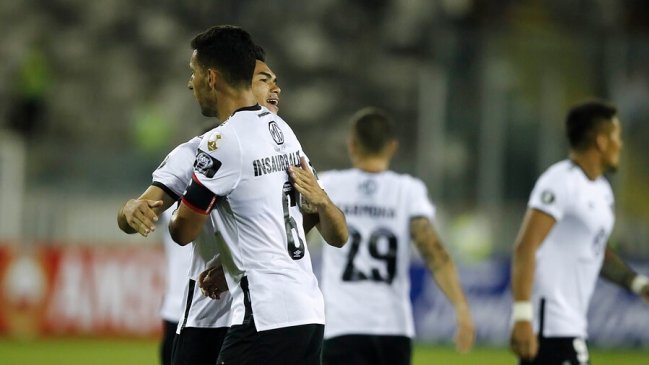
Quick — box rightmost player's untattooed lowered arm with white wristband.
[510,208,556,359]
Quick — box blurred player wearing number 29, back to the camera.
[320,108,474,365]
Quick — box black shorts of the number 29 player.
[322,335,412,365]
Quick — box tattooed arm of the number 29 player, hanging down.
[410,217,475,352]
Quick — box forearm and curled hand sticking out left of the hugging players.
[117,185,175,237]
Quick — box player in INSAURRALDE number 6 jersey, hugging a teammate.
[169,26,347,365]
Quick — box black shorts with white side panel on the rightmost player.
[519,337,590,365]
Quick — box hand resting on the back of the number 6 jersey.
[288,157,330,214]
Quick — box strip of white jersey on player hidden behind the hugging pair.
[158,208,192,323]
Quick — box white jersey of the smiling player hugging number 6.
[152,137,231,331]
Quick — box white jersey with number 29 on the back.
[320,169,435,338]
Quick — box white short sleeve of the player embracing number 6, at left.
[152,137,199,198]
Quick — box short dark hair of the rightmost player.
[566,100,617,151]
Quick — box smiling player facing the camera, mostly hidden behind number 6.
[118,47,281,365]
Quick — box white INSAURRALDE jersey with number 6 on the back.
[194,106,324,331]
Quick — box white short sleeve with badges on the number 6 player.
[194,124,242,196]
